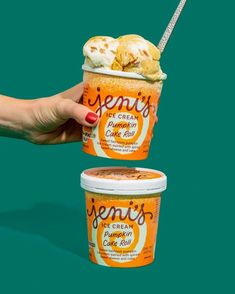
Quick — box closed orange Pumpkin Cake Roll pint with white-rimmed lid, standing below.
[81,167,166,267]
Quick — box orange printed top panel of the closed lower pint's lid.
[85,168,161,180]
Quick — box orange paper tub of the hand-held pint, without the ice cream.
[83,65,166,160]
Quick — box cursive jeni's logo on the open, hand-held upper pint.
[88,87,155,117]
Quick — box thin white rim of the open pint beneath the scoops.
[82,64,167,81]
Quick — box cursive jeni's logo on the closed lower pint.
[87,198,153,229]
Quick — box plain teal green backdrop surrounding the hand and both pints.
[0,0,235,294]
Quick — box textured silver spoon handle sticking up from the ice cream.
[157,0,186,53]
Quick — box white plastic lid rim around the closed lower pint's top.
[81,166,167,195]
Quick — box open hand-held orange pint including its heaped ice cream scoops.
[83,35,166,160]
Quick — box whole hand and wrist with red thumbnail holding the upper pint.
[0,83,98,144]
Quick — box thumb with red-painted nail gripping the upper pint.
[58,99,99,127]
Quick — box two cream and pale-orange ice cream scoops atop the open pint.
[83,35,162,81]
